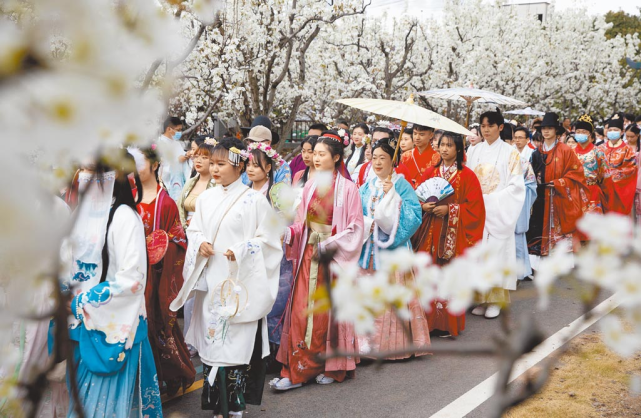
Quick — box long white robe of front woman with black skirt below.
[170,179,283,367]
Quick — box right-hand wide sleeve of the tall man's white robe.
[479,149,525,239]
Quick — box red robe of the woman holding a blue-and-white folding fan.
[412,166,485,336]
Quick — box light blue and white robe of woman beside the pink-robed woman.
[358,173,422,270]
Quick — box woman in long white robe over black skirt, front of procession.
[171,138,283,417]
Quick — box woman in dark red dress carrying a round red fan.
[129,146,196,396]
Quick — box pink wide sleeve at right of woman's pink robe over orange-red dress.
[318,179,363,267]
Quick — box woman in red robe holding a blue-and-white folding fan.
[412,132,485,336]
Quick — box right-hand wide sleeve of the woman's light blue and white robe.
[374,178,422,249]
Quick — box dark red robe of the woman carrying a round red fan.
[138,189,196,394]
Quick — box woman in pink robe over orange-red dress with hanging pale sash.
[270,130,363,390]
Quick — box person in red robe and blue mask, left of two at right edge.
[574,115,614,214]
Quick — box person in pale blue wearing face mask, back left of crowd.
[158,116,191,201]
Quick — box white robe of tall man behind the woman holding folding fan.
[467,139,525,290]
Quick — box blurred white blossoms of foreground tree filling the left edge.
[0,0,220,416]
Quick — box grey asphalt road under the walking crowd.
[163,282,604,418]
